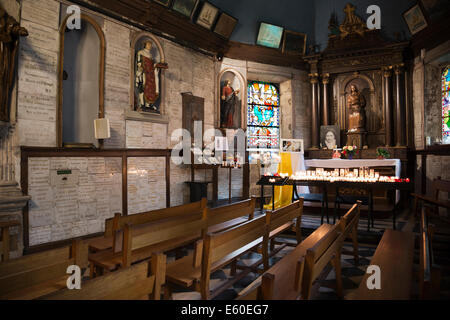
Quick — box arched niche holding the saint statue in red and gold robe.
[132,33,168,114]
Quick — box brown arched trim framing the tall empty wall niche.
[56,13,106,148]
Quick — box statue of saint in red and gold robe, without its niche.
[136,41,168,112]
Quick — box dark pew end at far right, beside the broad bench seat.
[419,208,441,300]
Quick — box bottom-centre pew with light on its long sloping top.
[237,224,334,300]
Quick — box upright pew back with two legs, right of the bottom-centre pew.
[302,222,344,300]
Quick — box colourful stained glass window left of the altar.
[247,81,280,151]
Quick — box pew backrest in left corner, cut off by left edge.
[0,240,88,296]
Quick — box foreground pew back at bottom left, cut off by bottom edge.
[41,254,166,300]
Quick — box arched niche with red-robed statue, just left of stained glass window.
[219,71,244,129]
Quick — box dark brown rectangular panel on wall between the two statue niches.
[182,93,205,139]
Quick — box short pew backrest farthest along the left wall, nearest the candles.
[207,199,256,226]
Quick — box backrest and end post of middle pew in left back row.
[119,208,206,267]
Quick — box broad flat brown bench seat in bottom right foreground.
[349,229,414,300]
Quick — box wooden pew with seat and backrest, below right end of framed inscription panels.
[89,208,206,277]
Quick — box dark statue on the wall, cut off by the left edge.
[0,7,28,121]
